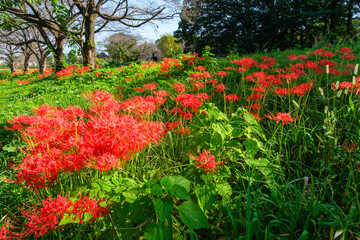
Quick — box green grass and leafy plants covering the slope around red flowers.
[0,46,360,239]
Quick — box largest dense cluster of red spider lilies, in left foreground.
[7,91,166,189]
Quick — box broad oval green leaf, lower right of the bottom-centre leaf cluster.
[178,201,209,229]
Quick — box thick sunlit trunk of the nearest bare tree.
[81,5,96,69]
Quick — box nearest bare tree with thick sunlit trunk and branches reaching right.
[68,0,176,68]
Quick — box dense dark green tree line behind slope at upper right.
[175,0,360,55]
